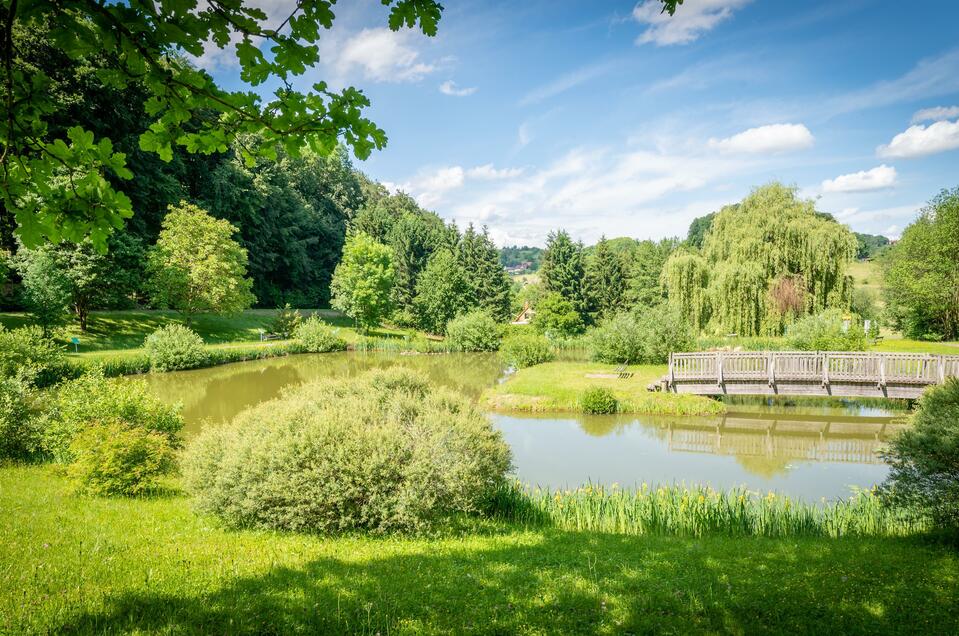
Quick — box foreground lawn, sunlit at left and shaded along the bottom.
[0,466,959,634]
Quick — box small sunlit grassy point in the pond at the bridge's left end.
[482,362,725,415]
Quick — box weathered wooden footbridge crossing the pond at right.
[658,351,959,399]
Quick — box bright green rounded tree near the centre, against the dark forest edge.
[332,232,394,331]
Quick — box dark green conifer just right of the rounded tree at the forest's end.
[459,224,512,322]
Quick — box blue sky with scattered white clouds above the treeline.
[198,0,959,246]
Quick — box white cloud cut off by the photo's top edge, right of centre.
[633,0,750,46]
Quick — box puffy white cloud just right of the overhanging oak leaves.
[334,28,439,82]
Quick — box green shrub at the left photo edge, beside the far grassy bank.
[0,326,67,386]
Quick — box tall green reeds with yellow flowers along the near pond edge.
[493,482,929,538]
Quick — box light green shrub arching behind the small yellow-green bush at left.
[43,369,183,463]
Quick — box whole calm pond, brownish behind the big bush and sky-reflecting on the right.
[143,353,902,501]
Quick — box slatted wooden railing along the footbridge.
[667,351,959,386]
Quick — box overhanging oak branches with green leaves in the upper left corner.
[0,0,442,250]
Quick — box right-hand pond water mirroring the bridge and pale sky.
[494,413,903,500]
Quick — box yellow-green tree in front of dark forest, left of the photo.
[147,201,256,324]
